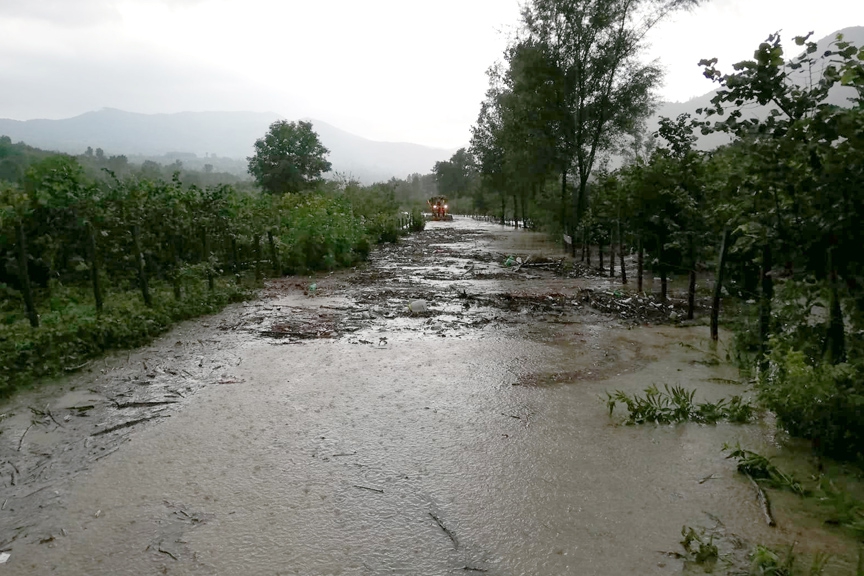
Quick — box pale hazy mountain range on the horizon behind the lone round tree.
[0,108,455,183]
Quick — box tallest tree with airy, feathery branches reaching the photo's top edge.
[522,0,699,251]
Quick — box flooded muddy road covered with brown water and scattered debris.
[0,219,854,576]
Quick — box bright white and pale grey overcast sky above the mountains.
[0,0,864,148]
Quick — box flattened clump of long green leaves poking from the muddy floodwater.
[606,384,753,424]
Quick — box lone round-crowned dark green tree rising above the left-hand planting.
[248,120,331,194]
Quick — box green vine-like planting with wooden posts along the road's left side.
[0,150,416,395]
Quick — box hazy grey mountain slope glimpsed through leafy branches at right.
[647,26,864,150]
